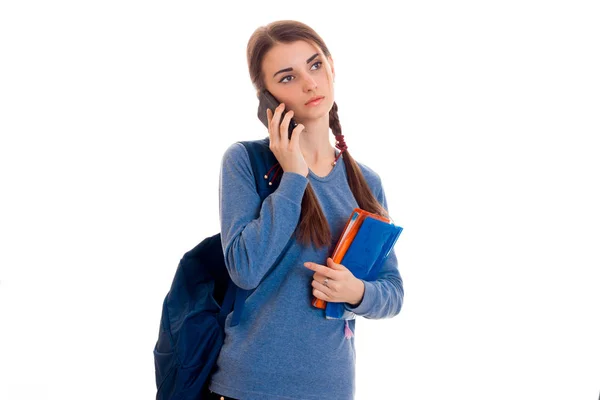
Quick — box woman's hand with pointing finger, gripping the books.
[304,257,365,307]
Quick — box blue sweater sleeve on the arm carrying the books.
[345,176,404,319]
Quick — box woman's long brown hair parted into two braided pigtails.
[246,20,387,247]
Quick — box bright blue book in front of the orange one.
[325,216,402,319]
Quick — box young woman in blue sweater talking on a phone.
[210,21,404,400]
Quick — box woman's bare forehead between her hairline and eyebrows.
[263,40,323,76]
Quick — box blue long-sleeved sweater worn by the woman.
[210,143,404,400]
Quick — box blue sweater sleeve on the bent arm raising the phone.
[219,143,308,289]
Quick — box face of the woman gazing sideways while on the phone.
[262,40,335,123]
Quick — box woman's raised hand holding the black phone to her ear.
[267,103,308,177]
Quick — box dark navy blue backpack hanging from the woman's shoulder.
[154,138,280,400]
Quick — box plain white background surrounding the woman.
[0,0,600,400]
